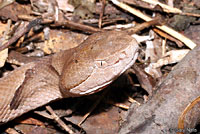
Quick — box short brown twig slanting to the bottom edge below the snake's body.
[46,106,74,134]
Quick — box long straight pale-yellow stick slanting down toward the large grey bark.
[111,0,196,49]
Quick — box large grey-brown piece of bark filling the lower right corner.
[119,46,200,134]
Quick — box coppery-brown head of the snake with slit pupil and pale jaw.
[59,31,138,97]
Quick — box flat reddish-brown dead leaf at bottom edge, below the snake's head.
[67,107,120,134]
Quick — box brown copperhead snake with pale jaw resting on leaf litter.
[0,31,138,123]
